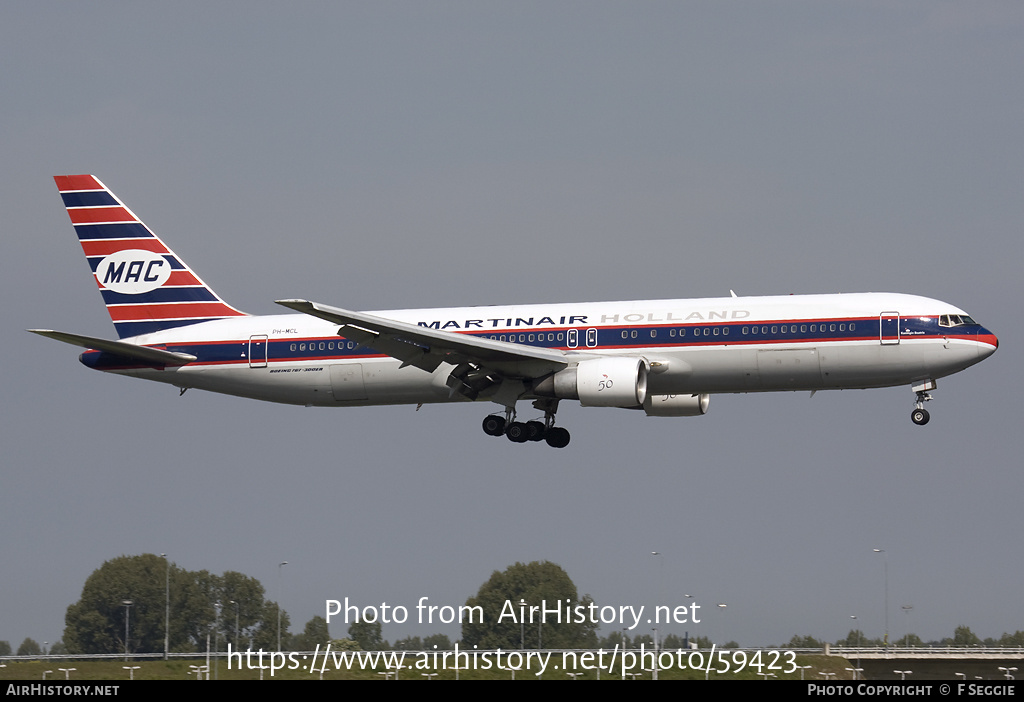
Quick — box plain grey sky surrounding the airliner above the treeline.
[0,1,1024,647]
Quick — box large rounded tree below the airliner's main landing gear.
[462,561,598,649]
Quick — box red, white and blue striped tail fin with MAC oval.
[53,175,245,339]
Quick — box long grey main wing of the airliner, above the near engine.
[276,300,571,386]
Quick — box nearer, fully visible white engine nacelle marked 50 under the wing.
[534,357,647,407]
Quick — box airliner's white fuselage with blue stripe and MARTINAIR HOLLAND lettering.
[83,293,997,406]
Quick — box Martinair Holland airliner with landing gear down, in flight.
[34,175,998,448]
